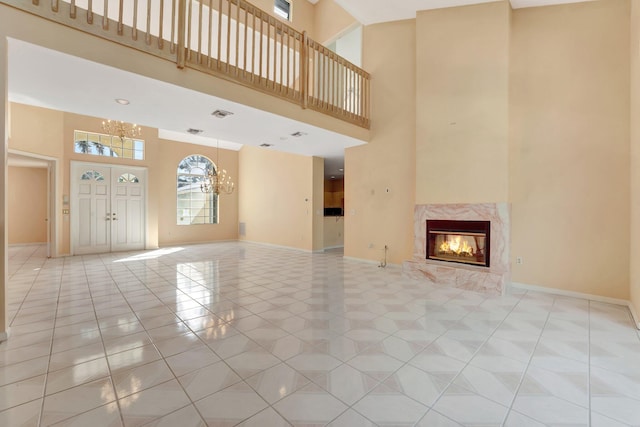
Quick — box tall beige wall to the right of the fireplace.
[509,1,630,299]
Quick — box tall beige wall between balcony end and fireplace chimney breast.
[344,20,416,264]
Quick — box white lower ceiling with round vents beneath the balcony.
[9,39,364,176]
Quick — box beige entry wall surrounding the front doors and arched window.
[9,104,239,255]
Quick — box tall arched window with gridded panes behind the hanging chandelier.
[177,154,218,225]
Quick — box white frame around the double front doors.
[69,160,149,255]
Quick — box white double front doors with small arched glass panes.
[71,162,146,255]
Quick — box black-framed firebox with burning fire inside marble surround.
[427,219,491,267]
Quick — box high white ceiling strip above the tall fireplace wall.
[335,0,593,25]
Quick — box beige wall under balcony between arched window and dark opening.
[239,146,322,251]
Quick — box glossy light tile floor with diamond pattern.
[0,243,640,427]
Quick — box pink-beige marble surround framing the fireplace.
[402,203,511,295]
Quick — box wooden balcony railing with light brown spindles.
[0,0,370,128]
